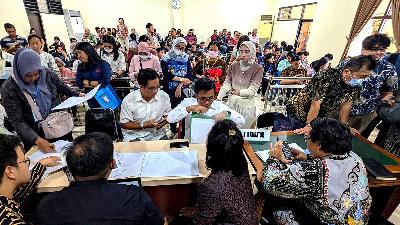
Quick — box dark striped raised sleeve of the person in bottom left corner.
[13,163,46,203]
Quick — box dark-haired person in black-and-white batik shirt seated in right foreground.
[259,117,372,225]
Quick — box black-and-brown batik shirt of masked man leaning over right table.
[286,68,360,123]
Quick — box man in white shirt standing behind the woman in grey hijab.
[28,34,60,75]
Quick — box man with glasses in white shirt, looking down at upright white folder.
[167,78,245,139]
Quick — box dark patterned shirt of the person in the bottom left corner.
[0,163,46,225]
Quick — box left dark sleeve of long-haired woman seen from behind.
[193,183,223,225]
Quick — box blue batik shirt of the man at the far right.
[339,59,398,115]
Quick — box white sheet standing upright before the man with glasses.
[190,117,215,144]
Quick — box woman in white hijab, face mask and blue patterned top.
[161,37,193,133]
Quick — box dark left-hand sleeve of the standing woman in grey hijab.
[1,83,39,144]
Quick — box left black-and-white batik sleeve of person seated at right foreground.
[263,158,323,199]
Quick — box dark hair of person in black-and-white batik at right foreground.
[310,117,352,155]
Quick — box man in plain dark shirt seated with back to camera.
[36,132,164,225]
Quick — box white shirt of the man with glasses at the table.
[167,98,245,139]
